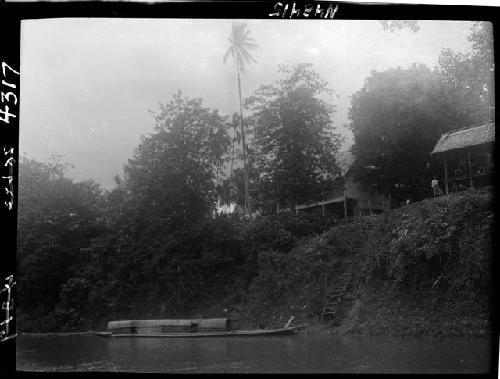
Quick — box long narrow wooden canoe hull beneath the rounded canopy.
[90,327,300,338]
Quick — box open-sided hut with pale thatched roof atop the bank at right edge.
[431,122,495,194]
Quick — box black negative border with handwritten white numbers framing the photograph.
[0,0,500,374]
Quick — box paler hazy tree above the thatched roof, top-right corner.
[439,22,495,127]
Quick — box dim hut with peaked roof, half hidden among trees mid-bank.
[278,151,390,218]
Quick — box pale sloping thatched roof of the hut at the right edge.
[431,122,495,154]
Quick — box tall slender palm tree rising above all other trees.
[223,22,257,215]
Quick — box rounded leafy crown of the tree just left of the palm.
[125,91,229,228]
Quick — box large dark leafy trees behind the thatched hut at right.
[350,23,494,203]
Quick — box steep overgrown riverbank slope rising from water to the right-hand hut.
[18,188,493,336]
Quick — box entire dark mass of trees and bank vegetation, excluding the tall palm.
[16,24,494,334]
